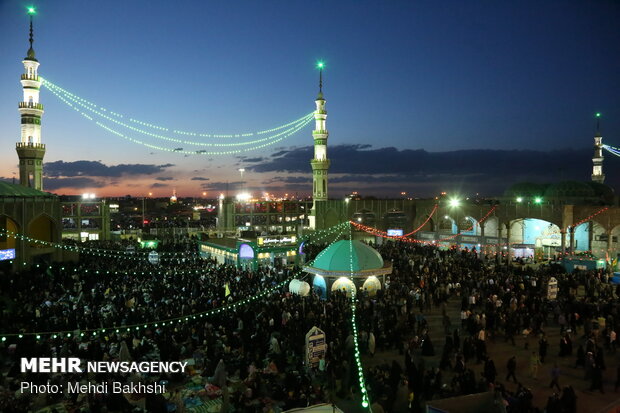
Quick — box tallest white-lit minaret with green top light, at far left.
[16,7,45,191]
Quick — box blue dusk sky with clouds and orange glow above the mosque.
[0,0,620,197]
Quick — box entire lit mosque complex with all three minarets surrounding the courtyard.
[0,10,620,265]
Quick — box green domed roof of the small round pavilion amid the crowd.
[312,240,383,272]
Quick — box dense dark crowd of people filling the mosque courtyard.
[0,233,620,413]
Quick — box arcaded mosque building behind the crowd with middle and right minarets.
[217,67,620,261]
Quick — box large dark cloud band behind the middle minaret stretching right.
[247,145,620,196]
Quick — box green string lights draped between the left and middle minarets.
[41,78,314,139]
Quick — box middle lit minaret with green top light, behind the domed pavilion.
[310,62,329,222]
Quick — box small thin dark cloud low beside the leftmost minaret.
[43,160,174,177]
